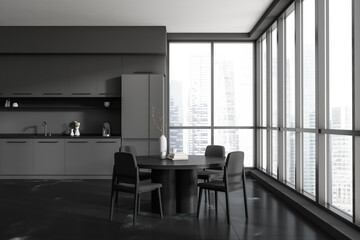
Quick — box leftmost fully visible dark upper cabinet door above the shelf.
[7,55,38,97]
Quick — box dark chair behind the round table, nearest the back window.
[198,145,225,203]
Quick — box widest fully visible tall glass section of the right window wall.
[328,0,353,215]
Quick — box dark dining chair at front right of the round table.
[196,151,248,224]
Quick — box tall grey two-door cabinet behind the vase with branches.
[121,74,165,154]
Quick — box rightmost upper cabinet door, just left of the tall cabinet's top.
[96,55,123,97]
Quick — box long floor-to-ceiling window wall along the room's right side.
[256,0,360,223]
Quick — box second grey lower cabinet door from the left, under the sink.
[33,139,65,174]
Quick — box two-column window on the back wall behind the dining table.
[169,42,254,167]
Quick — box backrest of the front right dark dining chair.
[224,151,245,184]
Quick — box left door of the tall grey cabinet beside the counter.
[121,74,150,138]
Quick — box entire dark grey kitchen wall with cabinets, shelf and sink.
[0,27,167,179]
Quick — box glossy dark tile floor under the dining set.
[0,178,332,240]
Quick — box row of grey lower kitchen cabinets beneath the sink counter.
[0,138,121,177]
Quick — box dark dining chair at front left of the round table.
[110,152,163,226]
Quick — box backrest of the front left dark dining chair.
[114,152,139,184]
